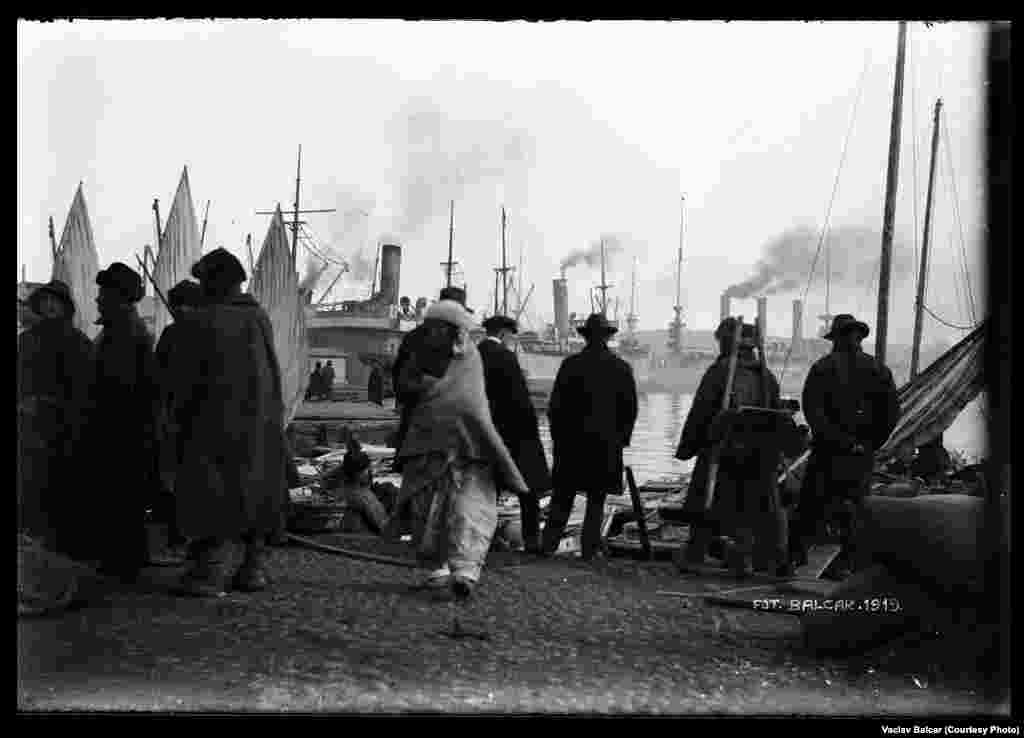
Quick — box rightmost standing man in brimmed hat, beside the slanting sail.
[791,314,899,564]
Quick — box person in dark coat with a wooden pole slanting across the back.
[676,317,796,575]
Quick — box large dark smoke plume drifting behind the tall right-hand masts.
[725,226,913,300]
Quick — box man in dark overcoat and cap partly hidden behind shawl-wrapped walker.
[477,315,551,554]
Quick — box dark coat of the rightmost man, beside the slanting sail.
[803,350,899,496]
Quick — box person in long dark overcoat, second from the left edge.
[79,262,160,581]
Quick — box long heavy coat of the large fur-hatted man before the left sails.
[173,295,288,539]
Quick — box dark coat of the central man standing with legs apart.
[548,344,637,493]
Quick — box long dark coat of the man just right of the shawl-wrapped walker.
[478,339,551,494]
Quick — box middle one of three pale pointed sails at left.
[153,167,203,339]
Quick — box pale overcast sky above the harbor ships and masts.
[17,20,985,343]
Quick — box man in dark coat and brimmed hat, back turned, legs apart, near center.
[541,313,637,560]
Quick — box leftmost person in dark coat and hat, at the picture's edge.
[17,280,92,549]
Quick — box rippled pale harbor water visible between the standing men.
[538,392,987,484]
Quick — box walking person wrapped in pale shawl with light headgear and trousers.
[387,300,528,598]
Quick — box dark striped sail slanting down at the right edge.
[876,323,986,462]
